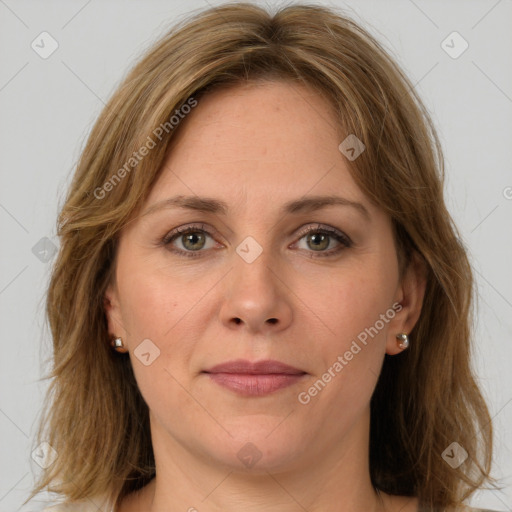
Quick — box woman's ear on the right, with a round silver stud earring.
[386,251,427,355]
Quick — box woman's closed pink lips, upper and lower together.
[203,359,306,396]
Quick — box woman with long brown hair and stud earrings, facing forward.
[26,4,498,512]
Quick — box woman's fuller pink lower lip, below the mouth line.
[207,373,306,396]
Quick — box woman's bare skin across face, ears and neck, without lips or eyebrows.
[105,82,425,512]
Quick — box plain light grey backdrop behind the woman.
[0,0,512,512]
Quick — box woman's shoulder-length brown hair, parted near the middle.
[27,3,492,508]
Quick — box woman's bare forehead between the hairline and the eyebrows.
[149,81,362,208]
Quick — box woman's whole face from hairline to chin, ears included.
[106,82,421,471]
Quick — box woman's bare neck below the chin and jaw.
[121,406,385,512]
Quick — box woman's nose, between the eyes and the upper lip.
[220,244,294,335]
